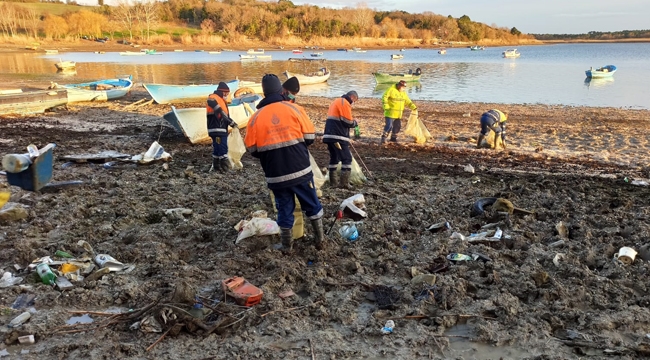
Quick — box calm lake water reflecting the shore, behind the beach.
[0,43,650,109]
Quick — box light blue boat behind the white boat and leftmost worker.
[143,80,239,104]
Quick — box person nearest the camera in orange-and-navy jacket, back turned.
[244,74,324,252]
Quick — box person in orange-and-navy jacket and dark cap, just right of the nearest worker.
[323,90,359,189]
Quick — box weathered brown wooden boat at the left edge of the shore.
[0,89,68,115]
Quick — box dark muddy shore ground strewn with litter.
[0,89,650,359]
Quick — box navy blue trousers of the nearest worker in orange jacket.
[272,177,323,229]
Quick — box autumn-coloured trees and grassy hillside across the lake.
[0,0,532,43]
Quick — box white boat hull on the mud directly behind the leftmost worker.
[163,94,262,144]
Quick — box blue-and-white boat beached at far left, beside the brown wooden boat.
[53,76,133,103]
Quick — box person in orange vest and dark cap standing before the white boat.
[206,81,238,172]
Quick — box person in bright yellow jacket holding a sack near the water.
[381,80,418,144]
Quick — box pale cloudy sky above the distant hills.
[293,0,650,34]
